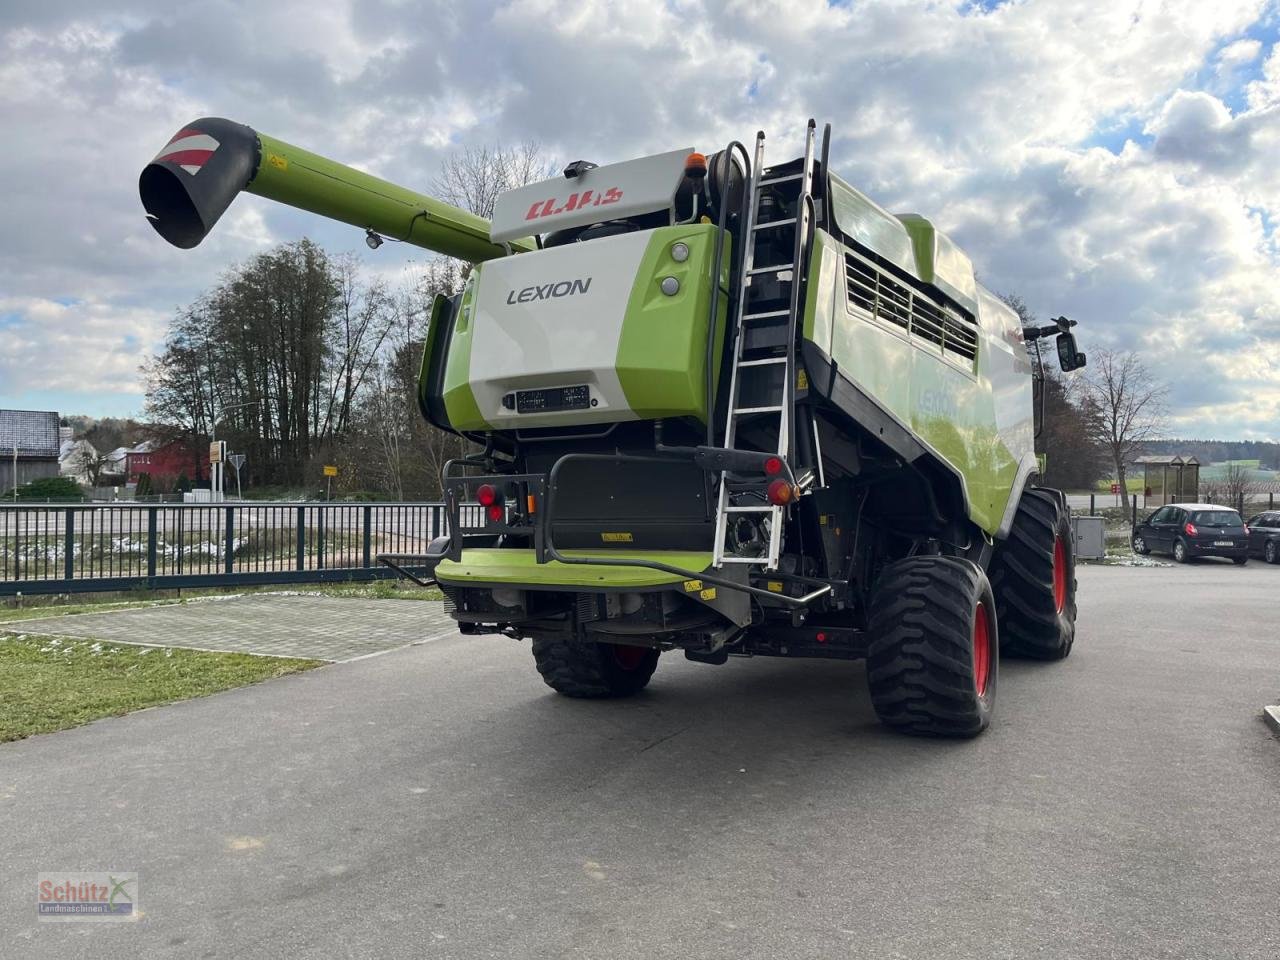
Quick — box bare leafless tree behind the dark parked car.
[1085,349,1169,519]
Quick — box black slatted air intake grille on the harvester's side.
[845,253,978,364]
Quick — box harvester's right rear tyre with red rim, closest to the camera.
[867,557,1000,737]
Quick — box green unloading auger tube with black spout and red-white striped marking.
[138,116,532,264]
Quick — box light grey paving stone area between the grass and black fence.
[8,594,457,660]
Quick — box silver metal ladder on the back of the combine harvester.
[713,120,815,570]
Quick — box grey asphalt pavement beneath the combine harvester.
[0,562,1280,960]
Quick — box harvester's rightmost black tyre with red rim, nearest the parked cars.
[991,486,1075,660]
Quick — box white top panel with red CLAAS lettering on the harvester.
[489,147,692,243]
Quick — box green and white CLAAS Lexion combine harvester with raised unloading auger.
[140,118,1084,736]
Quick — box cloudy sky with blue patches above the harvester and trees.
[0,0,1280,440]
